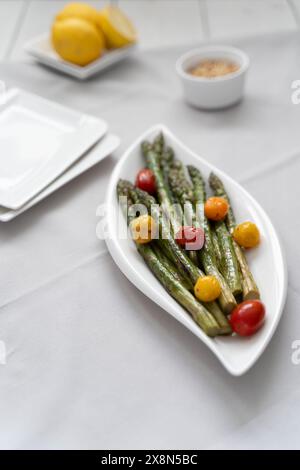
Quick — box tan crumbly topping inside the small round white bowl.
[188,59,240,78]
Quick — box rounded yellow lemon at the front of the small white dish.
[52,18,104,66]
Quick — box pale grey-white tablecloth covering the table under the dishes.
[0,34,300,449]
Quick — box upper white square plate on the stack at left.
[0,89,107,209]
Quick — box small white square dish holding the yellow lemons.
[24,34,136,80]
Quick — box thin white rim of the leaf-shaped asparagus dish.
[106,124,287,376]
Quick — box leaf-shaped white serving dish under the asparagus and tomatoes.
[107,124,287,376]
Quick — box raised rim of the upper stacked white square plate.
[0,88,107,209]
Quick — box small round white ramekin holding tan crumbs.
[176,46,249,109]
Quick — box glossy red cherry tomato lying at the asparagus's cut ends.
[229,300,265,336]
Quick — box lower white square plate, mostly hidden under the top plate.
[0,134,120,222]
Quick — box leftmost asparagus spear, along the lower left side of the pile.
[117,180,221,337]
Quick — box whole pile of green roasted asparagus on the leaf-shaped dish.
[117,133,259,337]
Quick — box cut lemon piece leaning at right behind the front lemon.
[100,5,137,48]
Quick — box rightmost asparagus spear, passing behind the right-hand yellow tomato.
[209,173,260,300]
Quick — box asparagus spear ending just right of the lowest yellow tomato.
[188,165,236,314]
